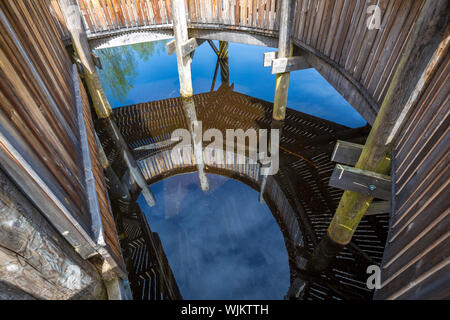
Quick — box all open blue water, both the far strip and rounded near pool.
[97,41,365,299]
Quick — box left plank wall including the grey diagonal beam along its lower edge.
[0,1,121,264]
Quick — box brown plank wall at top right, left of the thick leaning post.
[293,0,424,111]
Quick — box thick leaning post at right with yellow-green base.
[328,0,449,245]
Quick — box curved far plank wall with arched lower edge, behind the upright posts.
[50,0,432,124]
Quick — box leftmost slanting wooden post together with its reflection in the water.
[59,0,155,206]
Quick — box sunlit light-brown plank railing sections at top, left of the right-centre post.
[51,0,281,38]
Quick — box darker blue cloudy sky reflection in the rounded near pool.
[139,173,289,299]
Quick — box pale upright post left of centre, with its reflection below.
[171,0,209,191]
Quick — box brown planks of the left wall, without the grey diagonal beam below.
[0,1,121,264]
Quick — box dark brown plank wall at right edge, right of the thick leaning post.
[375,45,450,299]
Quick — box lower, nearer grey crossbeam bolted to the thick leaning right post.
[329,164,391,200]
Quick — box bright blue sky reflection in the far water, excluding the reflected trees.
[100,41,366,128]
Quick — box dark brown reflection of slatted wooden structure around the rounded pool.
[108,85,388,298]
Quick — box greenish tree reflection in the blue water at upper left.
[96,41,166,102]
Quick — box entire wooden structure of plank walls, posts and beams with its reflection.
[0,0,450,299]
